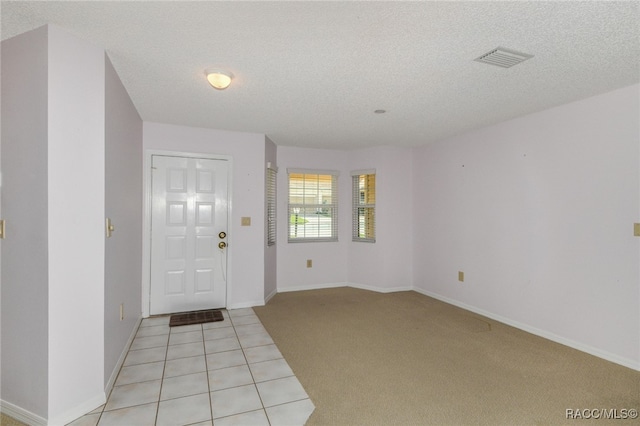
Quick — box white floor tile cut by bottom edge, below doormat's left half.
[156,393,211,426]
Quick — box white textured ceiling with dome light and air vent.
[0,1,640,150]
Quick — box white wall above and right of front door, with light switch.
[143,122,266,308]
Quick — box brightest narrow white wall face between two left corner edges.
[48,26,105,424]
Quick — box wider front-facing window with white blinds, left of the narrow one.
[288,169,338,243]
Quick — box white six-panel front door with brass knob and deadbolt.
[149,155,228,315]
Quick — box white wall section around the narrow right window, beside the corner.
[345,147,414,292]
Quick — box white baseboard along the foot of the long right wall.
[413,288,640,371]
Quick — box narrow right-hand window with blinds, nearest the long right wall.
[351,170,376,243]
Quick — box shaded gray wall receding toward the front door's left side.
[104,57,143,385]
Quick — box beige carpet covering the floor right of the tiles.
[254,288,640,425]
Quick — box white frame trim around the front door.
[142,149,233,318]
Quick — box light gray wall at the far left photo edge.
[0,24,49,418]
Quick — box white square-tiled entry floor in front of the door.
[70,308,315,426]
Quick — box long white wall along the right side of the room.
[413,85,640,368]
